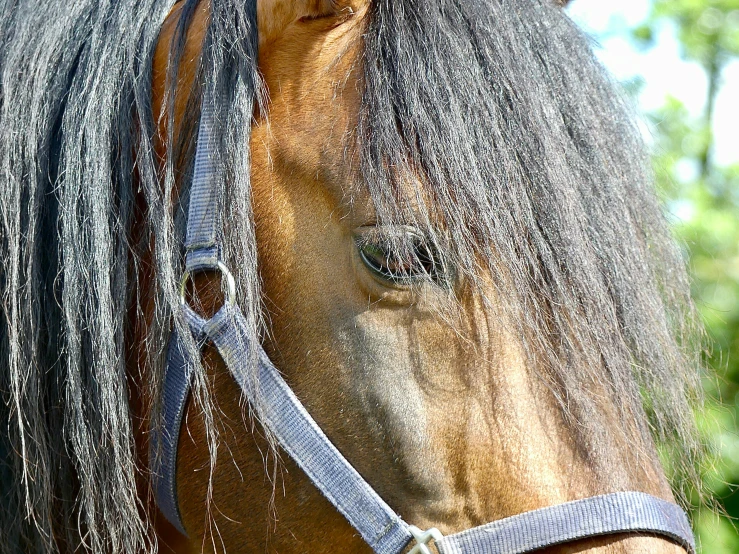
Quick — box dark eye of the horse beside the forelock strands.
[357,232,446,284]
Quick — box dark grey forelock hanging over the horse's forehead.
[357,0,700,476]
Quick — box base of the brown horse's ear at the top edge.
[257,0,369,44]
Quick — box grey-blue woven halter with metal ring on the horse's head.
[150,70,695,554]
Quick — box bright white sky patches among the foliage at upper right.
[568,0,739,165]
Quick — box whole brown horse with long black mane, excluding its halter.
[0,0,701,553]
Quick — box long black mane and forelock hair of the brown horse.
[0,0,699,553]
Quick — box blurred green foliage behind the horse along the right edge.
[631,0,739,554]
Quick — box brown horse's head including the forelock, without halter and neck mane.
[149,0,700,552]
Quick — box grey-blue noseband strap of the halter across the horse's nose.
[436,492,695,554]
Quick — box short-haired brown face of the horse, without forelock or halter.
[154,0,680,552]
